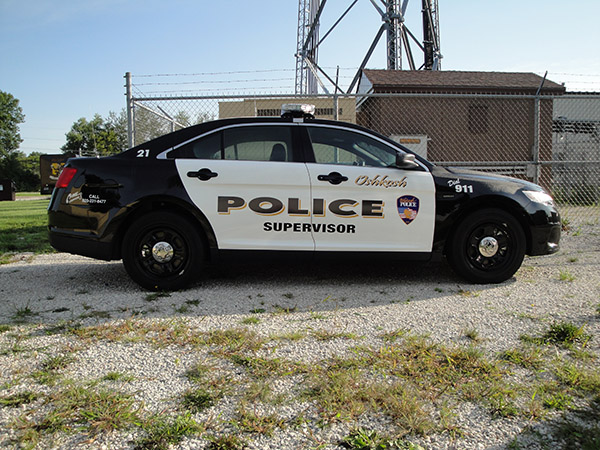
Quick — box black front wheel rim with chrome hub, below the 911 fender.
[467,223,513,271]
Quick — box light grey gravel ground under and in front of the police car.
[0,220,600,449]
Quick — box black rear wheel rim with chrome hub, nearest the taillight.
[137,228,189,278]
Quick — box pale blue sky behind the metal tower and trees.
[0,0,600,153]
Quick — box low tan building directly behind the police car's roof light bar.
[219,97,356,123]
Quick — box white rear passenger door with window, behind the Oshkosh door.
[174,123,314,251]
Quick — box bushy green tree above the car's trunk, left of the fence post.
[61,111,127,156]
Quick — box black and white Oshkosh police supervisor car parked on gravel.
[48,105,560,290]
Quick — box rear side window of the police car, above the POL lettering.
[169,126,293,162]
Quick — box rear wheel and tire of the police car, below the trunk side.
[122,212,205,291]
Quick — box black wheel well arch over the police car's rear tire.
[113,198,217,259]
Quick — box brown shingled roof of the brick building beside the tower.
[358,69,565,94]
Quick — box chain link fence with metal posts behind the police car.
[128,88,600,227]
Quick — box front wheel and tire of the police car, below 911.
[447,208,526,283]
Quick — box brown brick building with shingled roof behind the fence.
[357,70,565,181]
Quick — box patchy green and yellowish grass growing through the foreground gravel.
[5,316,600,449]
